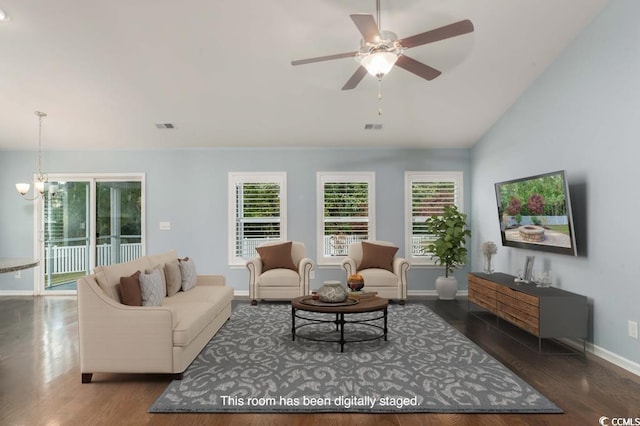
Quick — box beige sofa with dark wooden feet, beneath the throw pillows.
[78,251,233,383]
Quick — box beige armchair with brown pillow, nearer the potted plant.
[342,241,410,305]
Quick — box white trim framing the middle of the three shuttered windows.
[316,172,376,266]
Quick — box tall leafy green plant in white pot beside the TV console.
[425,206,471,300]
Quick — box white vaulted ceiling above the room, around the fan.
[0,0,607,150]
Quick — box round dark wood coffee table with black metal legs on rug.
[291,296,389,352]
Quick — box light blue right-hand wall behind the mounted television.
[472,0,640,368]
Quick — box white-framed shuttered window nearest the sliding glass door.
[229,172,287,265]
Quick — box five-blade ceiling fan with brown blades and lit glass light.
[291,0,473,90]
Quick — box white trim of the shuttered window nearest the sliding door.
[227,172,287,266]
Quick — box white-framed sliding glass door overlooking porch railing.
[36,175,144,294]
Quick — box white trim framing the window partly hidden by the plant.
[404,171,464,266]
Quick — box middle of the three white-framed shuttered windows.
[317,172,375,265]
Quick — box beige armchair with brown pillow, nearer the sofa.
[246,241,313,305]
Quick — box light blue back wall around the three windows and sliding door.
[0,149,471,291]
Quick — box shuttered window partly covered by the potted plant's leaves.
[404,172,462,265]
